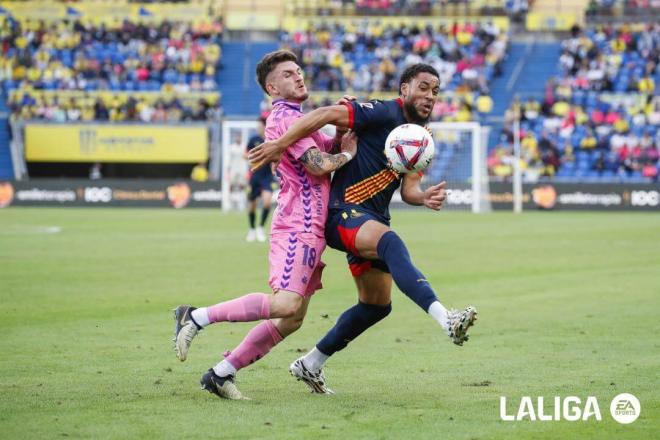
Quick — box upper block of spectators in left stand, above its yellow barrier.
[0,18,222,92]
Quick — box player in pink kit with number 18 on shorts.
[174,51,357,399]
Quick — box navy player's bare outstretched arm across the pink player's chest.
[248,105,350,170]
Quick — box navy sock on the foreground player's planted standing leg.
[316,302,392,356]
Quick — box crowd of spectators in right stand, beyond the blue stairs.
[488,24,660,182]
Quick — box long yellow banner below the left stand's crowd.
[25,124,208,163]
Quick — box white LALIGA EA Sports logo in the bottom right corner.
[500,393,641,424]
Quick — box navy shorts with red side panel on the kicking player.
[325,208,390,277]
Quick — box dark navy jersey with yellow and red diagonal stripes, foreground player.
[329,99,407,224]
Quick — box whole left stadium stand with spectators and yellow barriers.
[0,0,224,178]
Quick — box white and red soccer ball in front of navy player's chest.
[385,124,435,174]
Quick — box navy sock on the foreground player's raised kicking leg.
[376,231,438,312]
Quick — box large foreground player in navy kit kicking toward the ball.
[249,63,477,393]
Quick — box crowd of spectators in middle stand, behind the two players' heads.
[281,22,508,94]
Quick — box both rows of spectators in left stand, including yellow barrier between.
[0,18,222,122]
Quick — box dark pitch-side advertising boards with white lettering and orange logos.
[0,179,660,212]
